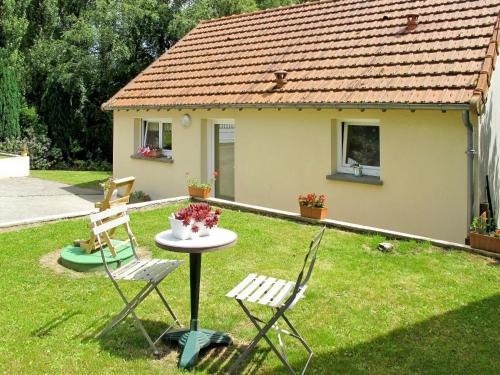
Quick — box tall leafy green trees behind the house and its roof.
[0,0,300,166]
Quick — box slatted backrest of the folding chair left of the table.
[90,205,137,273]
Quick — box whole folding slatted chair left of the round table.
[90,205,184,355]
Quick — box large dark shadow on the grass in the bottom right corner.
[261,294,500,375]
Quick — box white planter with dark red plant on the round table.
[168,203,221,240]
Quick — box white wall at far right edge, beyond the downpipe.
[478,59,500,226]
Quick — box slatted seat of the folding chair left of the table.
[112,259,182,281]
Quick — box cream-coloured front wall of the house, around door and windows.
[113,109,467,243]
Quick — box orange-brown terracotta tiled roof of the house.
[103,0,500,109]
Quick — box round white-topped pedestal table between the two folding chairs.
[155,228,238,368]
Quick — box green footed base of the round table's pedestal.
[163,328,233,369]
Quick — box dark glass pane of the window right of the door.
[344,125,380,167]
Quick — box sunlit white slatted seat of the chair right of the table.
[226,273,307,308]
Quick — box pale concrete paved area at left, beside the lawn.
[0,177,102,226]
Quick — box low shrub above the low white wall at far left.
[0,135,62,169]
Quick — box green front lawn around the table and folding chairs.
[0,206,500,375]
